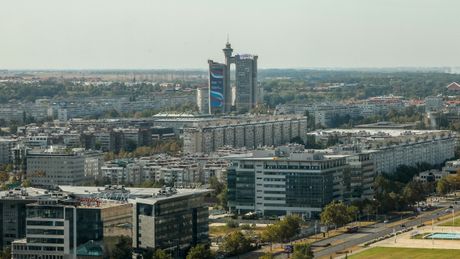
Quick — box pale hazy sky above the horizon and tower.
[0,0,460,69]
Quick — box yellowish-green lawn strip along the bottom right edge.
[349,247,460,259]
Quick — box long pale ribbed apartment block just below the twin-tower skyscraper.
[183,117,307,154]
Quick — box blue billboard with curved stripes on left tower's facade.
[209,63,225,113]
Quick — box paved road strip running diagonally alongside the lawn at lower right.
[315,210,450,257]
